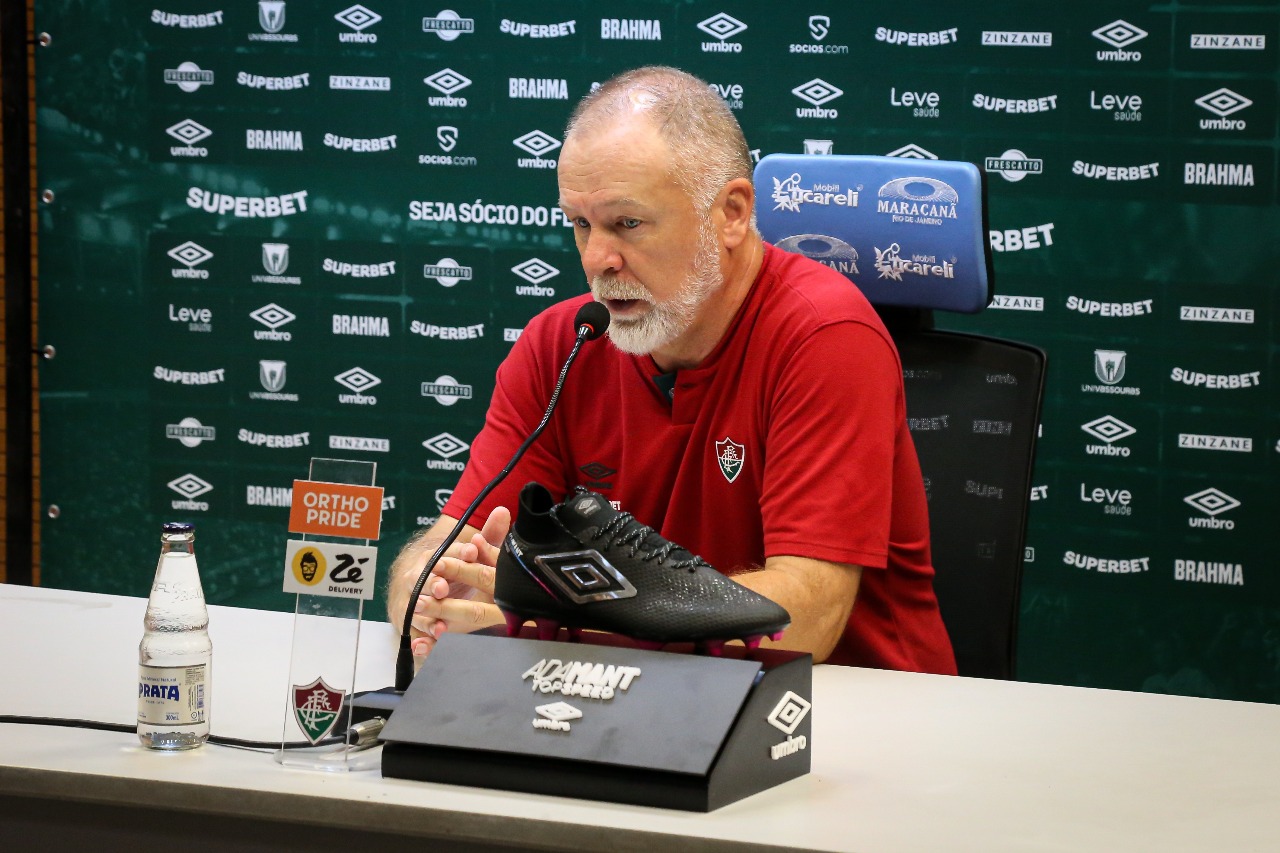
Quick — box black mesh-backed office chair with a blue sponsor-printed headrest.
[755,155,1046,679]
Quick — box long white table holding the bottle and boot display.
[0,585,1280,853]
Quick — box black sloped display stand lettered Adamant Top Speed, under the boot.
[381,634,813,812]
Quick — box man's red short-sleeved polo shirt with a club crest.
[444,246,955,672]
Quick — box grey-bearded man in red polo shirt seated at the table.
[389,67,955,672]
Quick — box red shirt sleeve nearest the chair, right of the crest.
[760,321,906,569]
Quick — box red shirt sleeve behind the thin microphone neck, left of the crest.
[443,312,576,528]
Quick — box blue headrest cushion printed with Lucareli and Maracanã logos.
[755,154,992,314]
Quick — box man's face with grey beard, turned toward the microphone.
[559,119,723,355]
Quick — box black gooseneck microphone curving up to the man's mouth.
[348,302,609,725]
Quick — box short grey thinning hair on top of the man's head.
[564,65,751,214]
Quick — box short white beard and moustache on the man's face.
[591,220,724,355]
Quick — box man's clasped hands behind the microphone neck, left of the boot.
[388,507,511,660]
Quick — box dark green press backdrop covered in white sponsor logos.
[36,0,1280,702]
